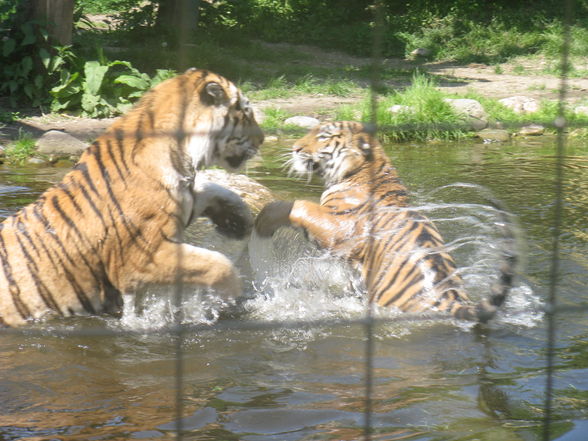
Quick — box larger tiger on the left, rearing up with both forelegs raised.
[0,68,264,327]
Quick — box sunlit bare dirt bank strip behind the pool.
[0,46,588,145]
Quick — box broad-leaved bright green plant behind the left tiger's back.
[50,53,175,118]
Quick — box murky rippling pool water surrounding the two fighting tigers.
[0,139,588,441]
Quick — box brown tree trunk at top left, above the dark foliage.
[32,0,74,46]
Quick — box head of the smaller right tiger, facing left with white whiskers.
[289,121,380,187]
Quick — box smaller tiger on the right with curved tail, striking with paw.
[254,121,516,322]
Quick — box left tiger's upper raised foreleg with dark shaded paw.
[192,181,253,239]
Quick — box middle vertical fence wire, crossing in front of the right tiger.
[363,0,384,441]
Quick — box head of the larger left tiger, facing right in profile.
[138,68,264,171]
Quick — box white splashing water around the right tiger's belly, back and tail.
[247,194,542,337]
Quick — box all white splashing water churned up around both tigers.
[112,185,542,334]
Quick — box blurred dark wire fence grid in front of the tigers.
[2,0,588,441]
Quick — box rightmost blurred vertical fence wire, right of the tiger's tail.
[543,0,572,441]
